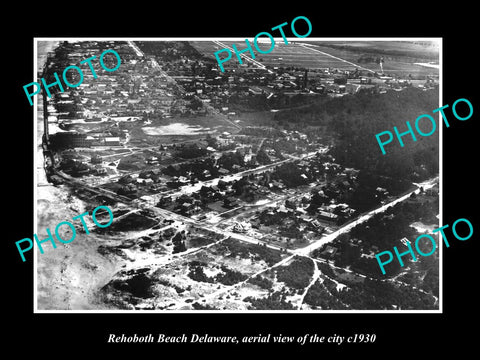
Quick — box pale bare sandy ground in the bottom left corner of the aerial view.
[36,186,123,310]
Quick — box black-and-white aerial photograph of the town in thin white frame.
[30,38,438,312]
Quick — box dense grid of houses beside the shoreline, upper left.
[49,41,202,124]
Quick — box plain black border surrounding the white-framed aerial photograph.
[6,3,480,357]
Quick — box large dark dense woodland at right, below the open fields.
[274,88,439,181]
